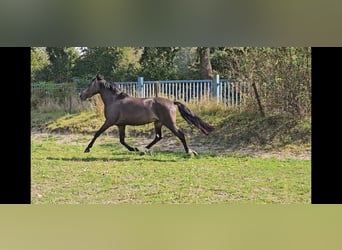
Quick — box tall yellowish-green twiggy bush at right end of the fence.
[212,47,311,116]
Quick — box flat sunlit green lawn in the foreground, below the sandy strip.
[31,134,311,204]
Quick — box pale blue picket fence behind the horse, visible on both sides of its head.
[31,75,249,107]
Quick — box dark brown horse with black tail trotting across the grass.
[80,74,214,155]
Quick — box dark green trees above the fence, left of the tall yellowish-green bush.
[31,47,208,83]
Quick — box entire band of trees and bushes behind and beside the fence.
[31,47,311,115]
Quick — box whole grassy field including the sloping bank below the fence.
[31,102,311,204]
